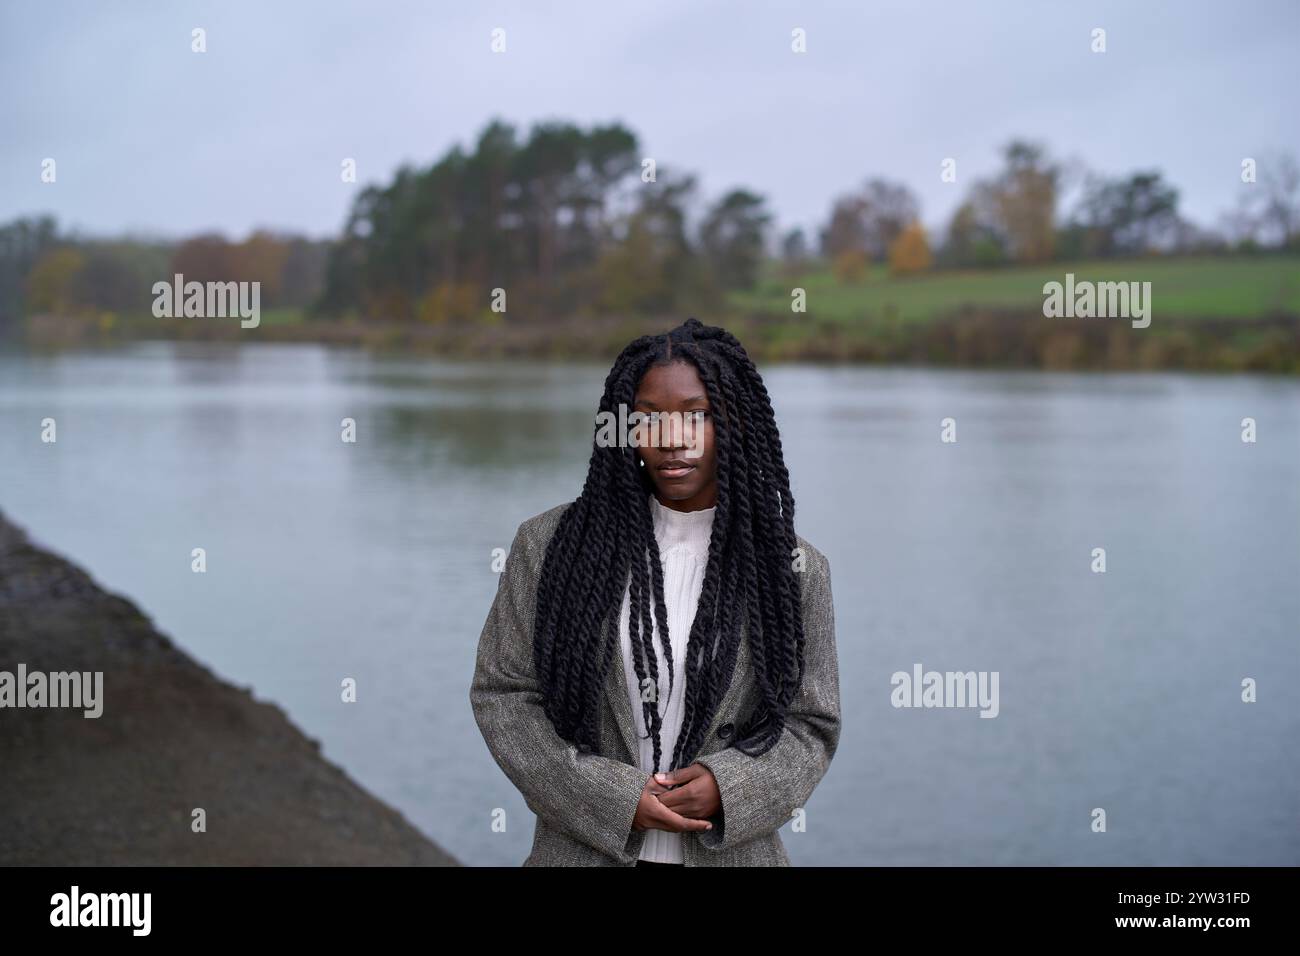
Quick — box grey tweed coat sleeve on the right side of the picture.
[696,548,840,849]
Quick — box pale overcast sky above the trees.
[0,0,1300,244]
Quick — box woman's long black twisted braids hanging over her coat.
[533,319,803,771]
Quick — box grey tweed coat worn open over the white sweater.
[469,505,840,866]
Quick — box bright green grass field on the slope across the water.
[729,256,1300,323]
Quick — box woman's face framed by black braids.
[633,360,718,511]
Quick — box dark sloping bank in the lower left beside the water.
[0,515,458,866]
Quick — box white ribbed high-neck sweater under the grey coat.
[620,496,716,864]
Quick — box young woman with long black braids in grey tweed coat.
[469,319,840,866]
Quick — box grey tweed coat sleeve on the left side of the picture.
[469,523,650,865]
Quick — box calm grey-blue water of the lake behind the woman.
[0,343,1300,865]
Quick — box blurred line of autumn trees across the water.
[0,121,1300,335]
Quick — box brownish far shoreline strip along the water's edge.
[13,308,1300,376]
